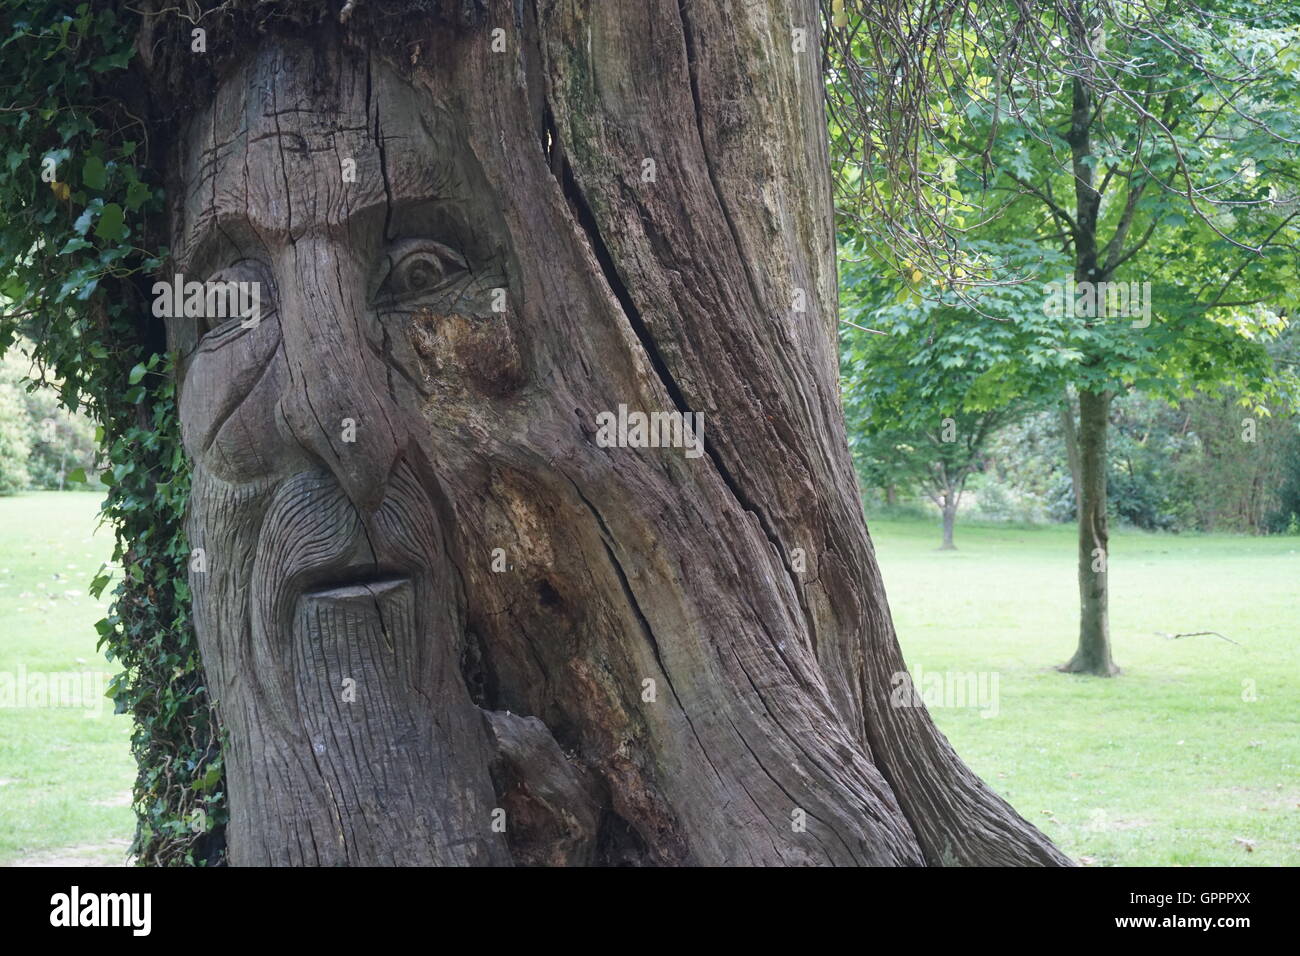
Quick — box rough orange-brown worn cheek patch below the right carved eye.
[407,310,524,398]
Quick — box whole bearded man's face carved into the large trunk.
[169,44,524,862]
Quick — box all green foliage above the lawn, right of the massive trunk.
[828,3,1300,546]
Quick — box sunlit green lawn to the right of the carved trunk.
[868,516,1300,866]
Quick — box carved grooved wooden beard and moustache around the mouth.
[190,459,508,865]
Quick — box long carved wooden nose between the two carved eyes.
[278,238,406,514]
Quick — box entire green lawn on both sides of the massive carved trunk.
[0,493,1300,865]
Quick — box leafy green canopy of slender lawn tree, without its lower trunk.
[943,5,1300,398]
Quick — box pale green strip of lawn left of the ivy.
[0,492,135,865]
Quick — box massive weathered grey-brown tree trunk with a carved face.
[154,0,1069,865]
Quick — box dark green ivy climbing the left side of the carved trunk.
[0,0,225,865]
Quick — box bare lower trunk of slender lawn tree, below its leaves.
[1061,392,1119,678]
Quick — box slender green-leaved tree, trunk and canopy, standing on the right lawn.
[831,0,1300,675]
